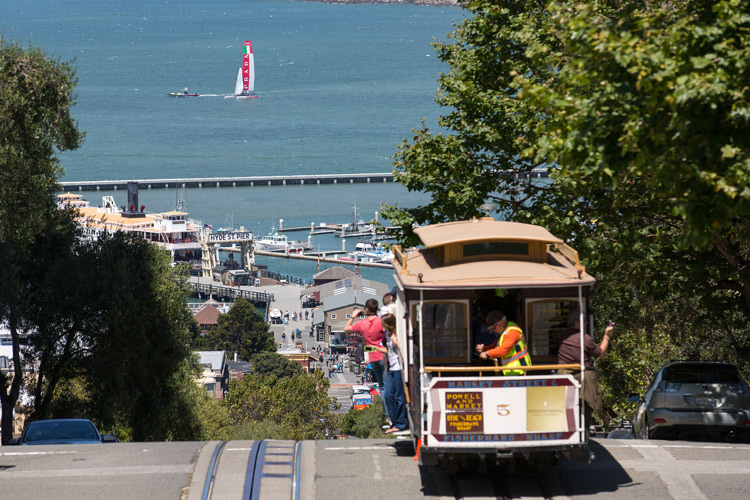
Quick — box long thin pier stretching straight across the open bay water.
[60,168,547,191]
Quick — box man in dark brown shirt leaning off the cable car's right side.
[557,309,614,433]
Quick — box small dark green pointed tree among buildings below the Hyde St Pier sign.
[206,299,276,360]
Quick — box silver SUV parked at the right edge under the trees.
[628,361,750,439]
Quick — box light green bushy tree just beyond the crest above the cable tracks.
[225,371,338,440]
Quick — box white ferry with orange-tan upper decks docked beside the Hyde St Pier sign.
[57,186,204,263]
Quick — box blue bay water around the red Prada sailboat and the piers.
[0,0,463,288]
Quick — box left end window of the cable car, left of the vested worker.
[411,301,470,365]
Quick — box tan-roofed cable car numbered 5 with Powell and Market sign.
[393,217,595,465]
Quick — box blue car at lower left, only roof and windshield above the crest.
[8,418,117,446]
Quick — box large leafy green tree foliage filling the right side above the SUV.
[384,0,750,422]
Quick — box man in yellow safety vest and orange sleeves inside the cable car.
[476,311,531,375]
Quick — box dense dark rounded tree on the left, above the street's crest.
[82,233,200,441]
